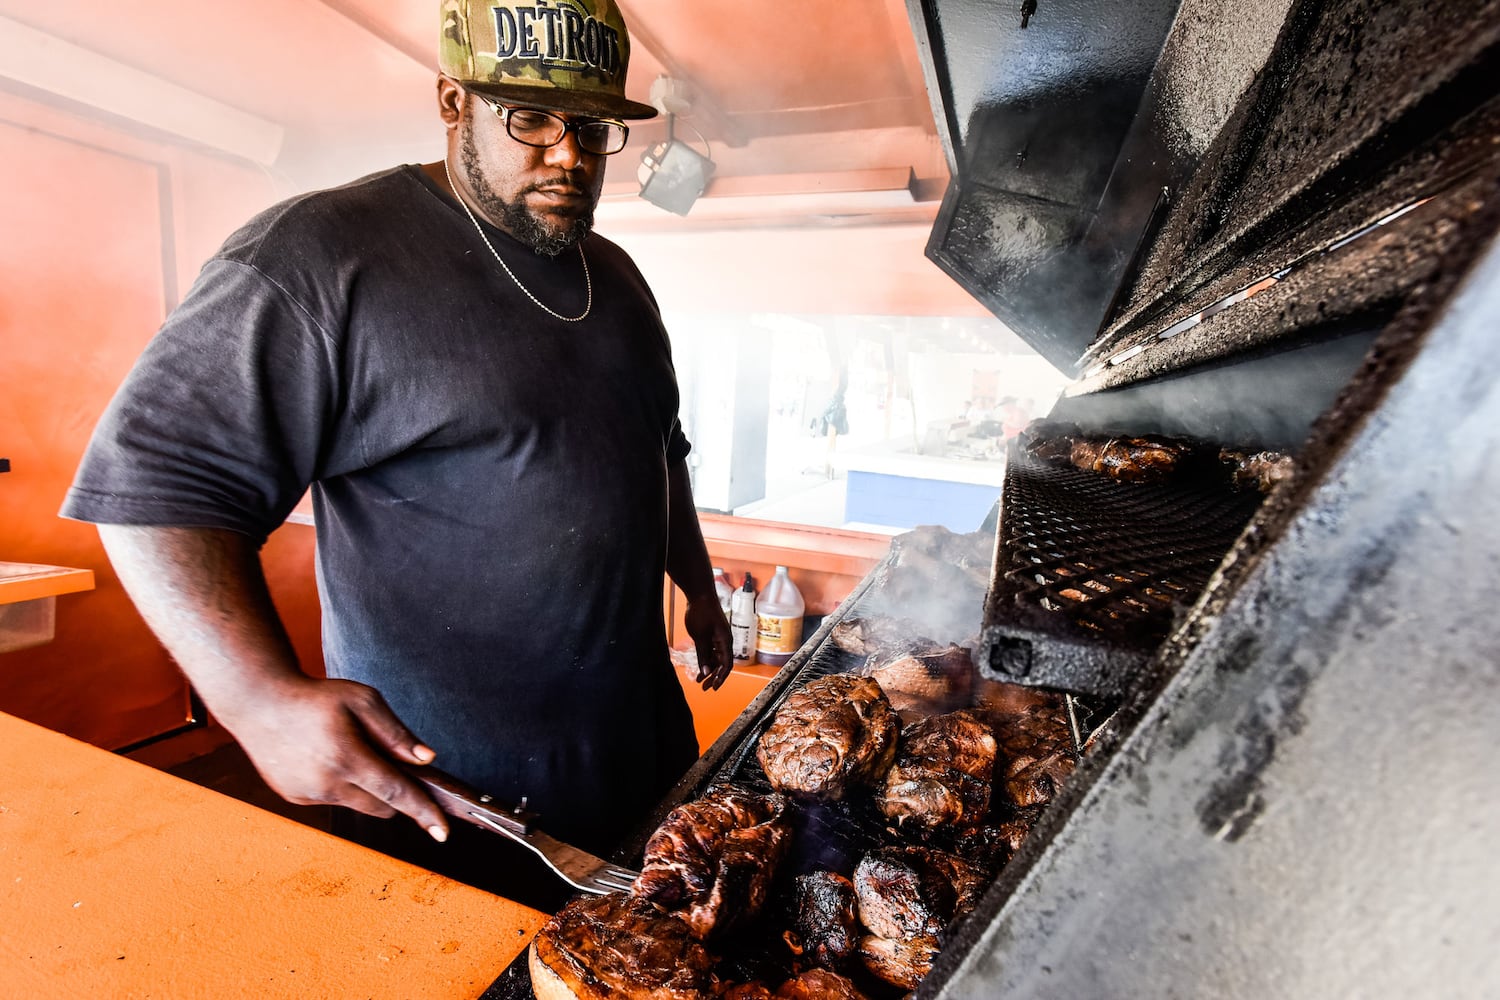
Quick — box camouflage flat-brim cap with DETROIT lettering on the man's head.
[438,0,657,118]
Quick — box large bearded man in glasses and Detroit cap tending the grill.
[63,0,732,898]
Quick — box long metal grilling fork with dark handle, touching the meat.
[402,765,641,895]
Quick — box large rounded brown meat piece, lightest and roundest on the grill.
[756,673,900,799]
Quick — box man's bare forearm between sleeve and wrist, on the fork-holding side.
[99,525,300,716]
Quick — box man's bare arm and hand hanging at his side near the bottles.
[666,460,735,691]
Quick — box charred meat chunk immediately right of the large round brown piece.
[876,711,996,831]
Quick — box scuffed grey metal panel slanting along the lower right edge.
[924,224,1500,1000]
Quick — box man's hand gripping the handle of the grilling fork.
[219,678,449,841]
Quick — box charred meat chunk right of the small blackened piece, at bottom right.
[854,847,984,990]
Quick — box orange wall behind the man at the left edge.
[0,93,321,748]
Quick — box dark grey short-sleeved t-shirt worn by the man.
[63,166,696,844]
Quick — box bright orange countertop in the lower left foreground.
[0,712,546,1000]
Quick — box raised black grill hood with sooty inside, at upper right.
[908,0,1500,383]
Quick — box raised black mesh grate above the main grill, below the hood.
[980,445,1262,697]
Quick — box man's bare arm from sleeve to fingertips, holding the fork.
[99,525,449,840]
